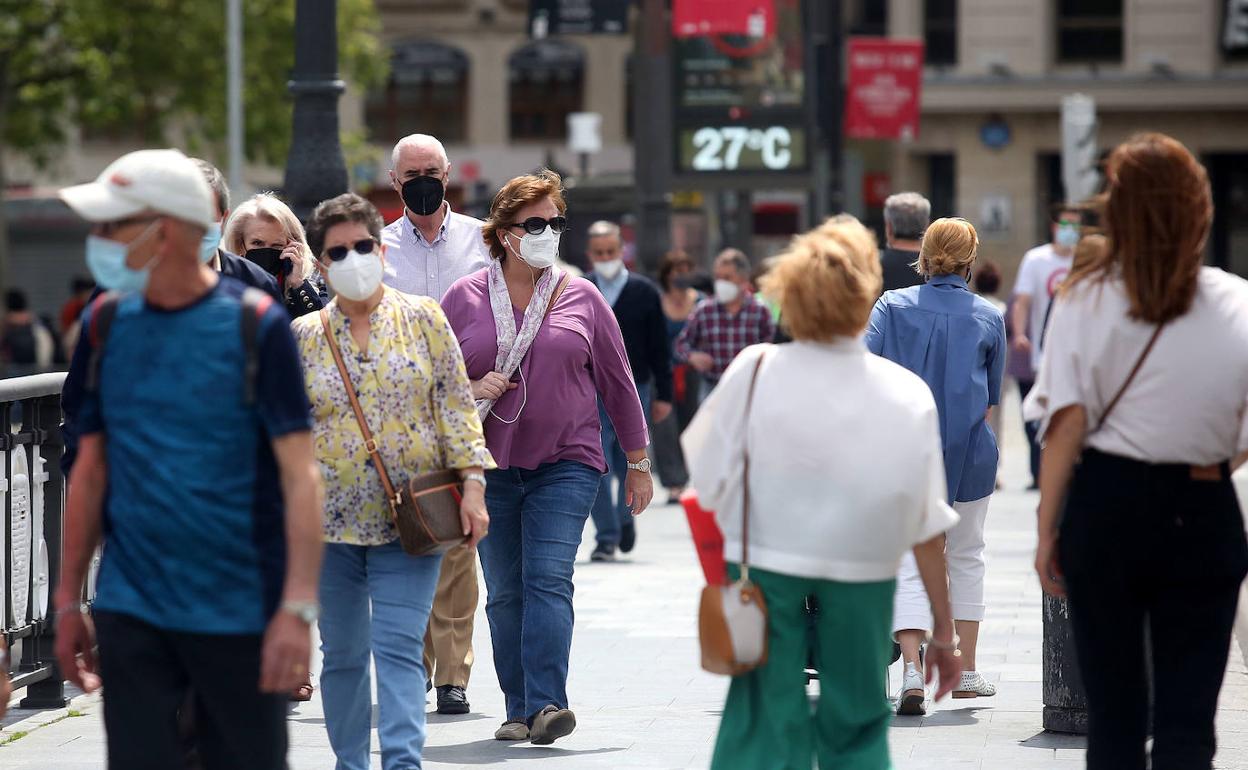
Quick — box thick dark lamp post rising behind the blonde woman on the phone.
[286,0,348,221]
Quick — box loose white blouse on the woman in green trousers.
[680,338,957,583]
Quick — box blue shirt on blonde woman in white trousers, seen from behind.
[866,276,1006,503]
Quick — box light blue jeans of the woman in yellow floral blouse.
[321,540,442,770]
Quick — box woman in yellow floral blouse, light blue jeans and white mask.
[295,193,494,770]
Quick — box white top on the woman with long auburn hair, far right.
[1023,267,1248,465]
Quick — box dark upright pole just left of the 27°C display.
[633,0,673,276]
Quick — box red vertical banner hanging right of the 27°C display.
[845,37,924,140]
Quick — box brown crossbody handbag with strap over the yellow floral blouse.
[321,308,468,557]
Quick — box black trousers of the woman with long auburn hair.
[1058,449,1248,770]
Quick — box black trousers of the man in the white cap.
[95,612,287,770]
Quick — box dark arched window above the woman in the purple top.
[508,39,585,141]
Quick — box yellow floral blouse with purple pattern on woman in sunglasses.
[292,287,495,545]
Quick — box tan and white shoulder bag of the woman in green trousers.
[698,353,768,676]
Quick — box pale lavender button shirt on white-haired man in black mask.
[382,203,489,301]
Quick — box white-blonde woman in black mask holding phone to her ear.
[221,192,329,318]
